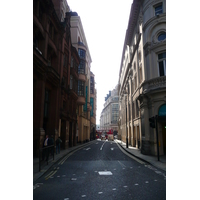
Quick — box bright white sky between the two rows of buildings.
[67,0,133,124]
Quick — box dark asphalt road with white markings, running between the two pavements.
[33,140,166,200]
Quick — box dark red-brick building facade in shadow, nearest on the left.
[33,0,80,156]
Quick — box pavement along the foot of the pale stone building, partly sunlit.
[115,139,166,171]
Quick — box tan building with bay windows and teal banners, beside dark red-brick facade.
[70,12,92,143]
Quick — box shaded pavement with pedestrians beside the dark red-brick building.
[33,140,96,182]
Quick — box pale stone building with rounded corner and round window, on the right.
[118,0,166,155]
